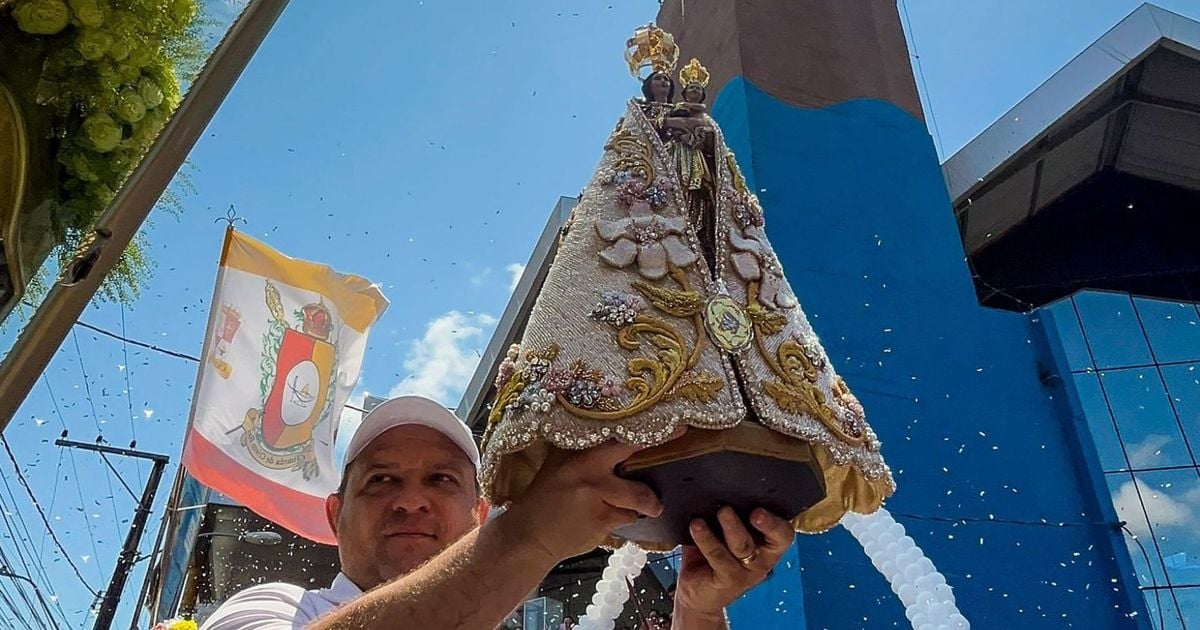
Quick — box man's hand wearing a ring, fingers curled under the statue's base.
[674,508,796,630]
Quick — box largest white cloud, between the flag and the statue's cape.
[388,311,496,407]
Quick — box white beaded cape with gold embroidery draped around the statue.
[480,100,895,532]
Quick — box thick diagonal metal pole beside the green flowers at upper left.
[0,0,288,432]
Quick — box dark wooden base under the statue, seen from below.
[613,421,826,548]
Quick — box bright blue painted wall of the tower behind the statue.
[713,77,1146,629]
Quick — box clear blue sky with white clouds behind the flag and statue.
[0,0,1200,628]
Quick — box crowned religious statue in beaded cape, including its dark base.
[481,25,895,548]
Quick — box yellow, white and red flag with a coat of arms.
[184,229,388,544]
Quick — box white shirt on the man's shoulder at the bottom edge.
[200,574,362,630]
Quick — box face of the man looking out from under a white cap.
[325,425,487,590]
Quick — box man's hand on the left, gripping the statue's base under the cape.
[497,442,662,563]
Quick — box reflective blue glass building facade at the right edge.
[1045,292,1200,630]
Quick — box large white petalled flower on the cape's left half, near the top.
[596,202,697,280]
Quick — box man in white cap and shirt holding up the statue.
[203,396,793,630]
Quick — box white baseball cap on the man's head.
[342,396,479,474]
